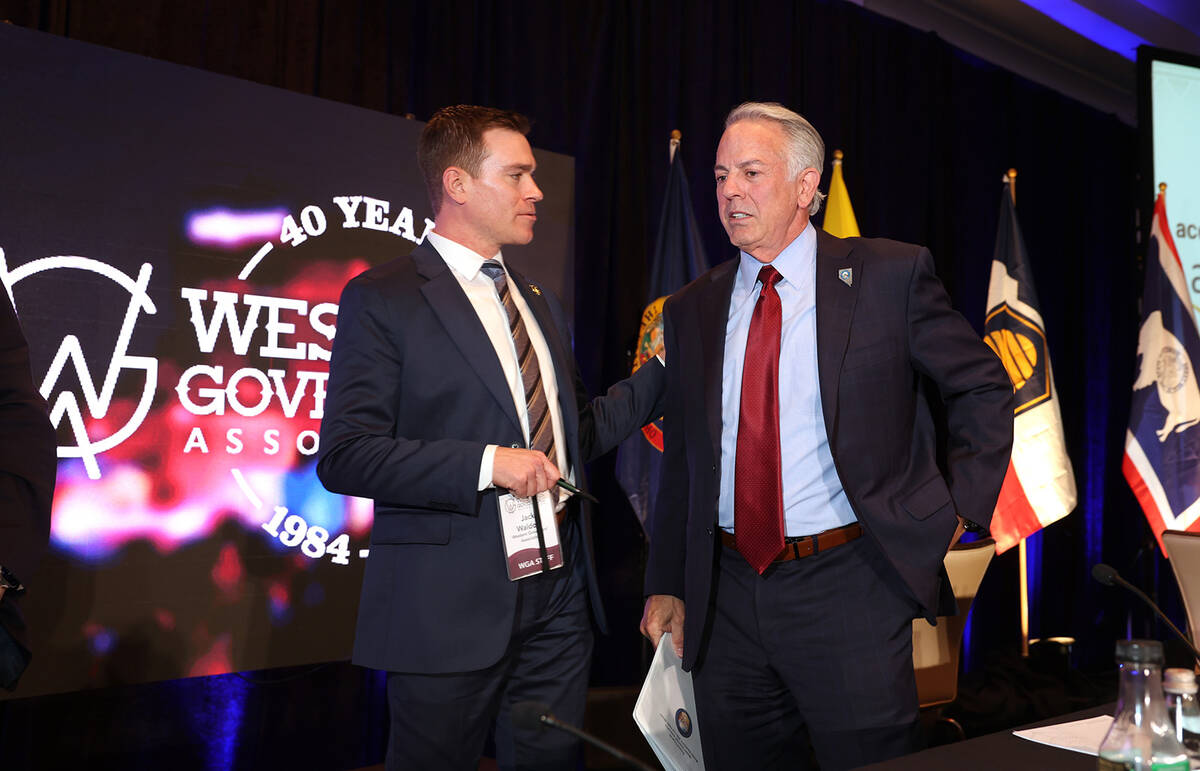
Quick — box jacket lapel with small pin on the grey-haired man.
[816,228,863,437]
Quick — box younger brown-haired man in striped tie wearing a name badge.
[318,106,665,769]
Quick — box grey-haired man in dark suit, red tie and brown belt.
[642,103,1013,771]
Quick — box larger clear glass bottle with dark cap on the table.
[1096,640,1189,771]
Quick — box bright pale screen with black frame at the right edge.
[1142,47,1200,300]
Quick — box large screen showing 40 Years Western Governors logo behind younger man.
[0,25,574,697]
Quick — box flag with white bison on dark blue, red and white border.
[1122,185,1200,554]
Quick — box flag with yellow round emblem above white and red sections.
[984,178,1075,554]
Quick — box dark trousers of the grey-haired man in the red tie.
[694,536,918,771]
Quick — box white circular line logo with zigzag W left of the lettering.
[0,249,158,479]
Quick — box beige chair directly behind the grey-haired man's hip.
[912,538,998,710]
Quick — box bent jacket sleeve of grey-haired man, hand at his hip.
[907,249,1013,527]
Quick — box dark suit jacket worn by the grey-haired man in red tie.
[646,229,1013,669]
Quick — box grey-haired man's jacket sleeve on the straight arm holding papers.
[644,299,689,599]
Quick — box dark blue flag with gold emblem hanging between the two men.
[617,132,708,533]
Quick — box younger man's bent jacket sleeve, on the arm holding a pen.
[317,276,486,514]
